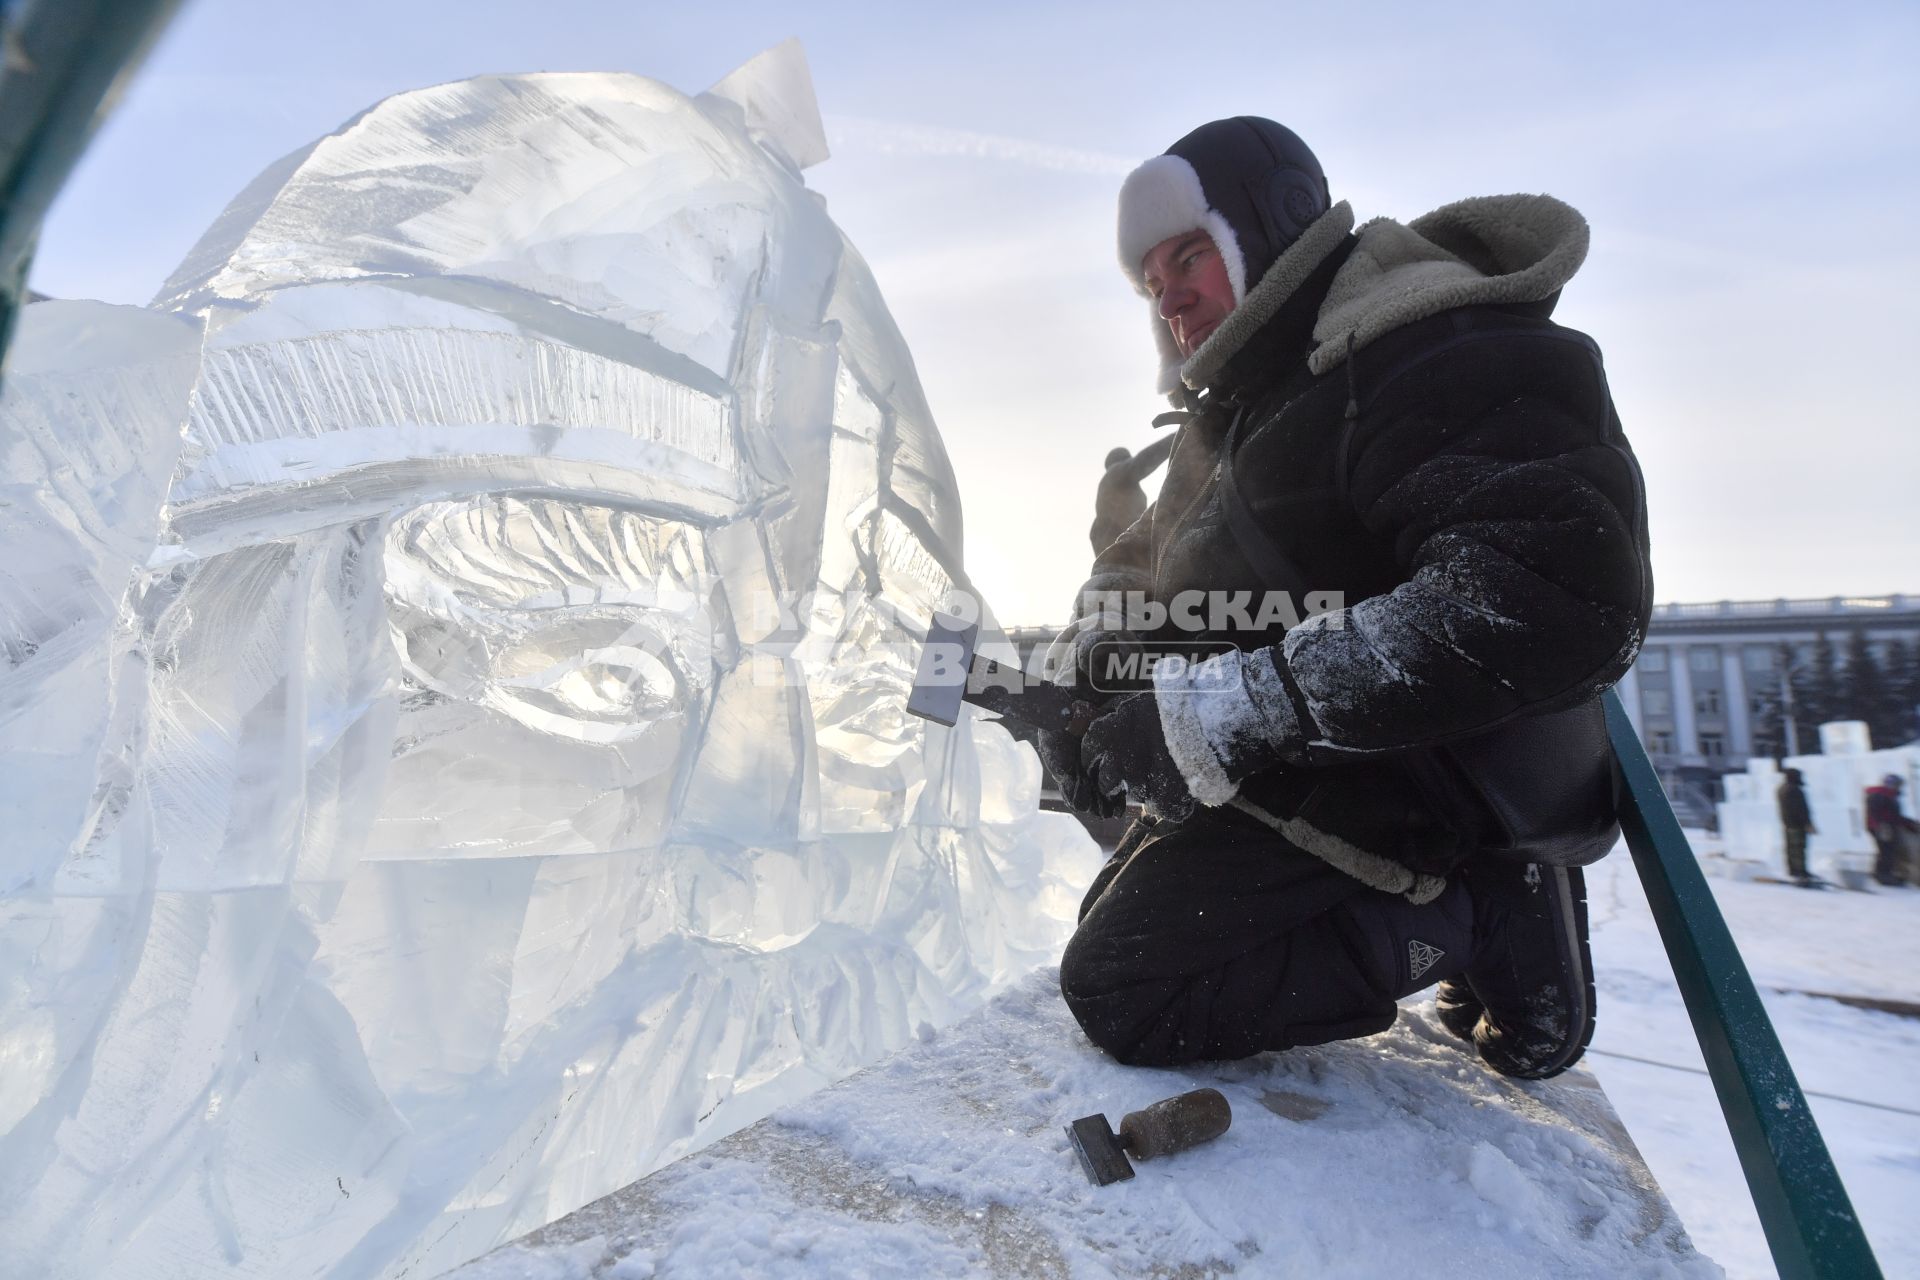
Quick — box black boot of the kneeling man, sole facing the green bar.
[1438,858,1594,1080]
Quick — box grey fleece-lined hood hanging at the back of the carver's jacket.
[1305,196,1588,374]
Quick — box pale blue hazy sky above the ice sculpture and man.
[33,0,1920,622]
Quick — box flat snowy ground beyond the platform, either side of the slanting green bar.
[1588,836,1920,1280]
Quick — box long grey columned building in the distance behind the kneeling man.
[1008,595,1920,825]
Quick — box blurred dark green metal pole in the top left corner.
[0,0,180,376]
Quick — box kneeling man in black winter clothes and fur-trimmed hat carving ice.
[1041,117,1651,1079]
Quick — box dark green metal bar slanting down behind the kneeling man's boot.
[1607,691,1880,1280]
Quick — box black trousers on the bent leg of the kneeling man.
[1060,808,1473,1065]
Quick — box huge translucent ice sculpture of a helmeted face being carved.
[0,46,1096,1280]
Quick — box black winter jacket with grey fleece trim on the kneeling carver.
[1081,198,1653,889]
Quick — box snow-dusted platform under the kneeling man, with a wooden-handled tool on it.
[451,969,1722,1280]
